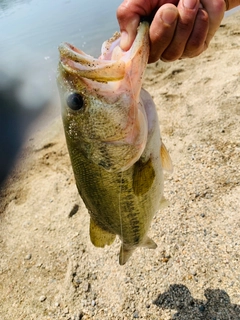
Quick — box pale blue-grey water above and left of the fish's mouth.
[0,0,122,117]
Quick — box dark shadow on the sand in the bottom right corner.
[153,284,240,320]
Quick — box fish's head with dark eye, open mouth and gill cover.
[57,22,149,171]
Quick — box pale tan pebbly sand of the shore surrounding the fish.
[0,12,240,320]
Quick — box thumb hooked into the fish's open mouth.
[117,0,179,51]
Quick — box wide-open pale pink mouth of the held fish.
[59,23,148,82]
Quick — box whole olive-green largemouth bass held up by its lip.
[57,22,172,265]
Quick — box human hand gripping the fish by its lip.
[117,0,226,63]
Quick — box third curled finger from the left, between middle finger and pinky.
[182,9,209,58]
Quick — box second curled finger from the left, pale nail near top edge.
[162,0,200,61]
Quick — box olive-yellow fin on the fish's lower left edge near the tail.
[90,219,116,248]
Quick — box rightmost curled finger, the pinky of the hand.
[201,0,226,47]
